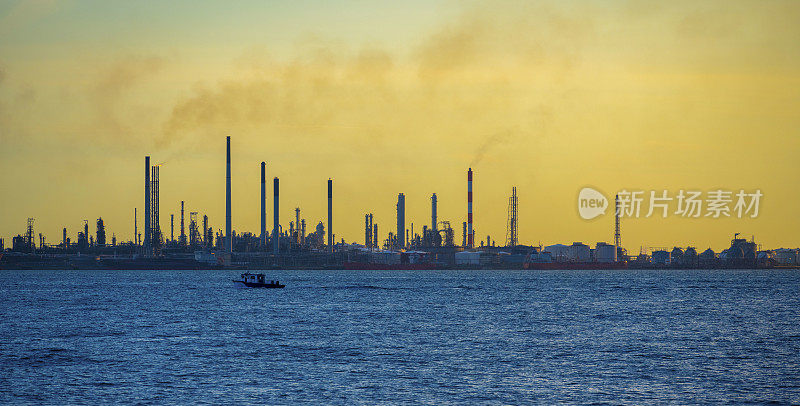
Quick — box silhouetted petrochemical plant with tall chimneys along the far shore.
[0,137,800,270]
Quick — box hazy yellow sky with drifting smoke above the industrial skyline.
[0,0,800,253]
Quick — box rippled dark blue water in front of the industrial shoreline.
[0,271,800,404]
